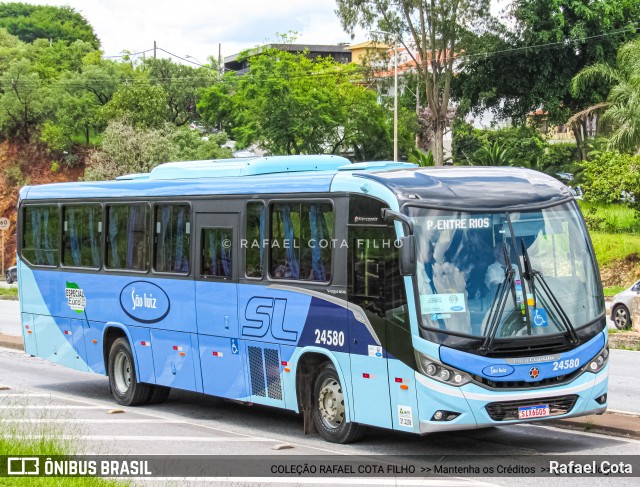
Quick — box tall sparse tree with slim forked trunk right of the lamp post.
[337,0,490,165]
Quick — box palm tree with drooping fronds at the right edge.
[572,38,640,153]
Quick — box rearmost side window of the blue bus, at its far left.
[22,205,60,266]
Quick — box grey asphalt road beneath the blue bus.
[0,348,640,487]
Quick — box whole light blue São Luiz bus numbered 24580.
[13,156,608,443]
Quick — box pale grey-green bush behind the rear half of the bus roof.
[84,121,231,181]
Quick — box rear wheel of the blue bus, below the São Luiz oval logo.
[109,338,153,406]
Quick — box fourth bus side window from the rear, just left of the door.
[153,205,191,274]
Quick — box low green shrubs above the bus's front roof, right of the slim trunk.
[452,122,547,169]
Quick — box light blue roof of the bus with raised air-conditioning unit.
[20,156,571,209]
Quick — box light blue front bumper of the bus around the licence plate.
[416,364,609,434]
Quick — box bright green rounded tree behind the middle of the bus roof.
[198,44,391,160]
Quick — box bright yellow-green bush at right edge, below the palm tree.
[583,152,640,206]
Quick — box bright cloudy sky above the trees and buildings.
[21,0,366,63]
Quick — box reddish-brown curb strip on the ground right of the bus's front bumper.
[547,411,640,438]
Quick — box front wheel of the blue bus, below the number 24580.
[311,363,365,444]
